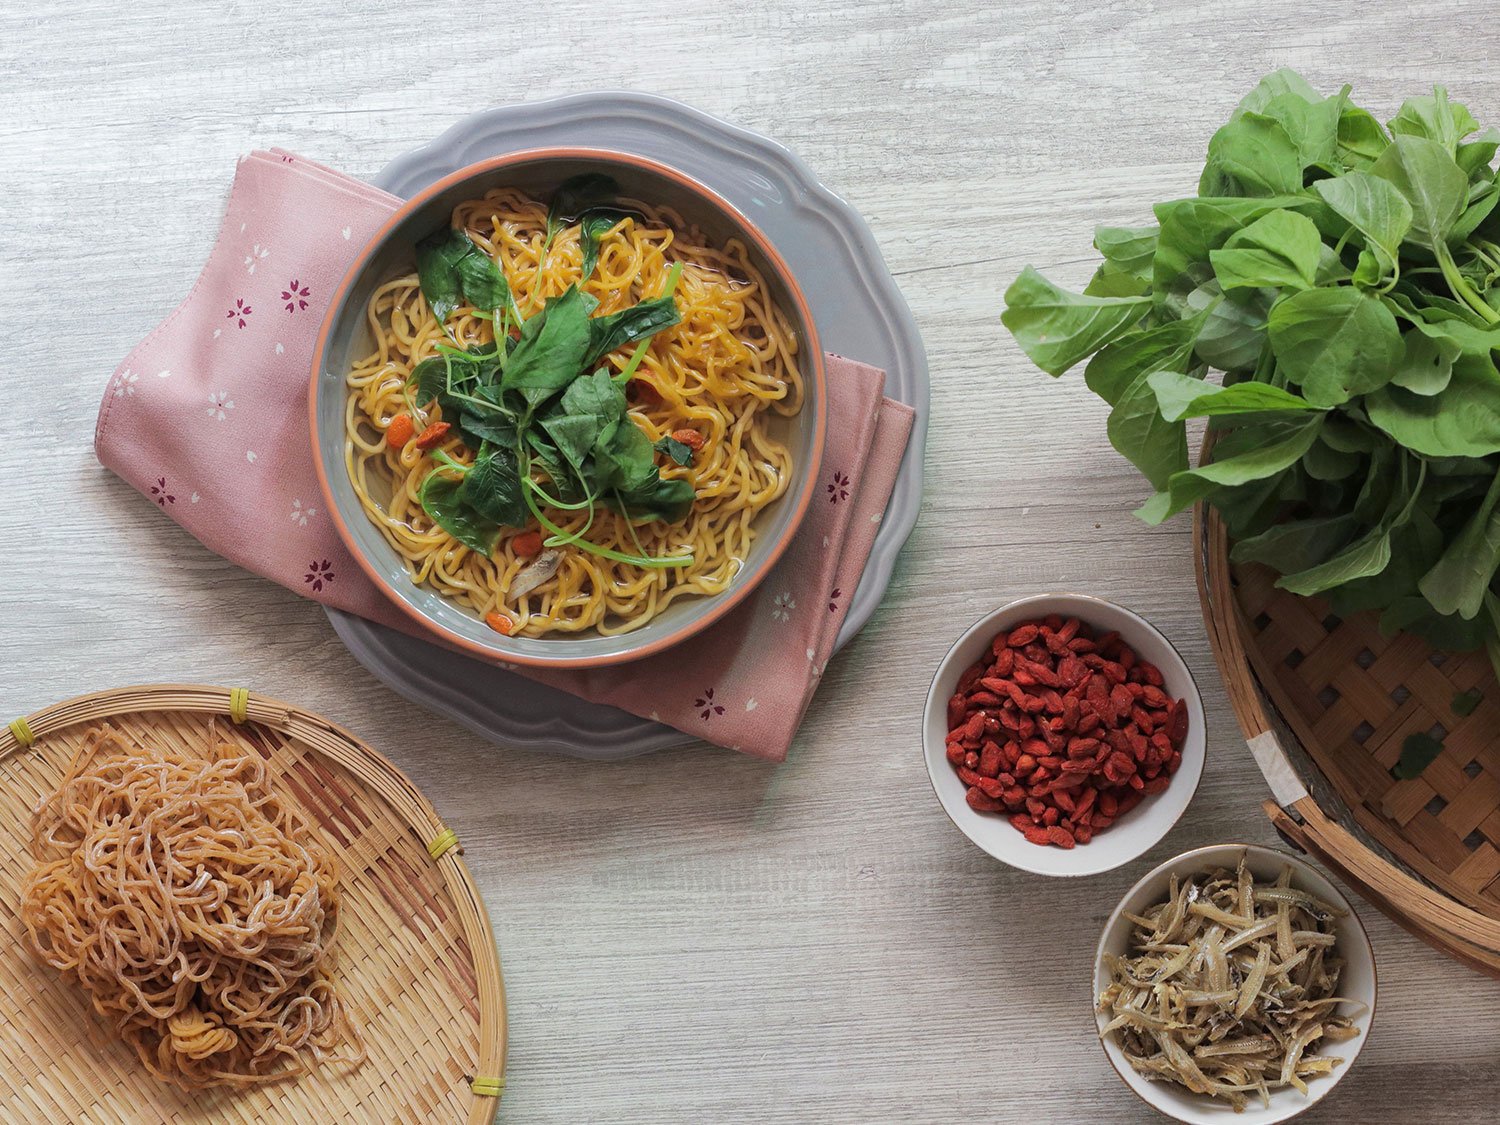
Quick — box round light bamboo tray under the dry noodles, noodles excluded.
[0,686,506,1125]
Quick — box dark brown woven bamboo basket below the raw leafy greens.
[1194,504,1500,977]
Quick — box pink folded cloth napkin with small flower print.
[95,150,914,761]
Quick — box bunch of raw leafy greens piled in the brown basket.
[1002,71,1500,663]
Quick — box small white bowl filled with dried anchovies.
[1094,845,1377,1125]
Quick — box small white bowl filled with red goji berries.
[923,594,1206,875]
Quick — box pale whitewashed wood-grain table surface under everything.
[0,0,1500,1124]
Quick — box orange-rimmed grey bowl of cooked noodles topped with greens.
[309,149,827,668]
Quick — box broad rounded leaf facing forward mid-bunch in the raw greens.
[1268,288,1403,407]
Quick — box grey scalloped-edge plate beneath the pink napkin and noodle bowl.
[327,92,930,761]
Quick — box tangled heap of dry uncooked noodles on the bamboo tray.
[21,726,365,1089]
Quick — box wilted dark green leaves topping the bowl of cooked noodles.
[408,176,693,567]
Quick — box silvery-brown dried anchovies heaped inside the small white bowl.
[1098,855,1359,1112]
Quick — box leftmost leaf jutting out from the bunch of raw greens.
[1001,266,1151,375]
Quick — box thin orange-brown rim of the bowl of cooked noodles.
[308,147,828,668]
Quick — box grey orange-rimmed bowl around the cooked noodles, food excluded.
[314,153,822,666]
